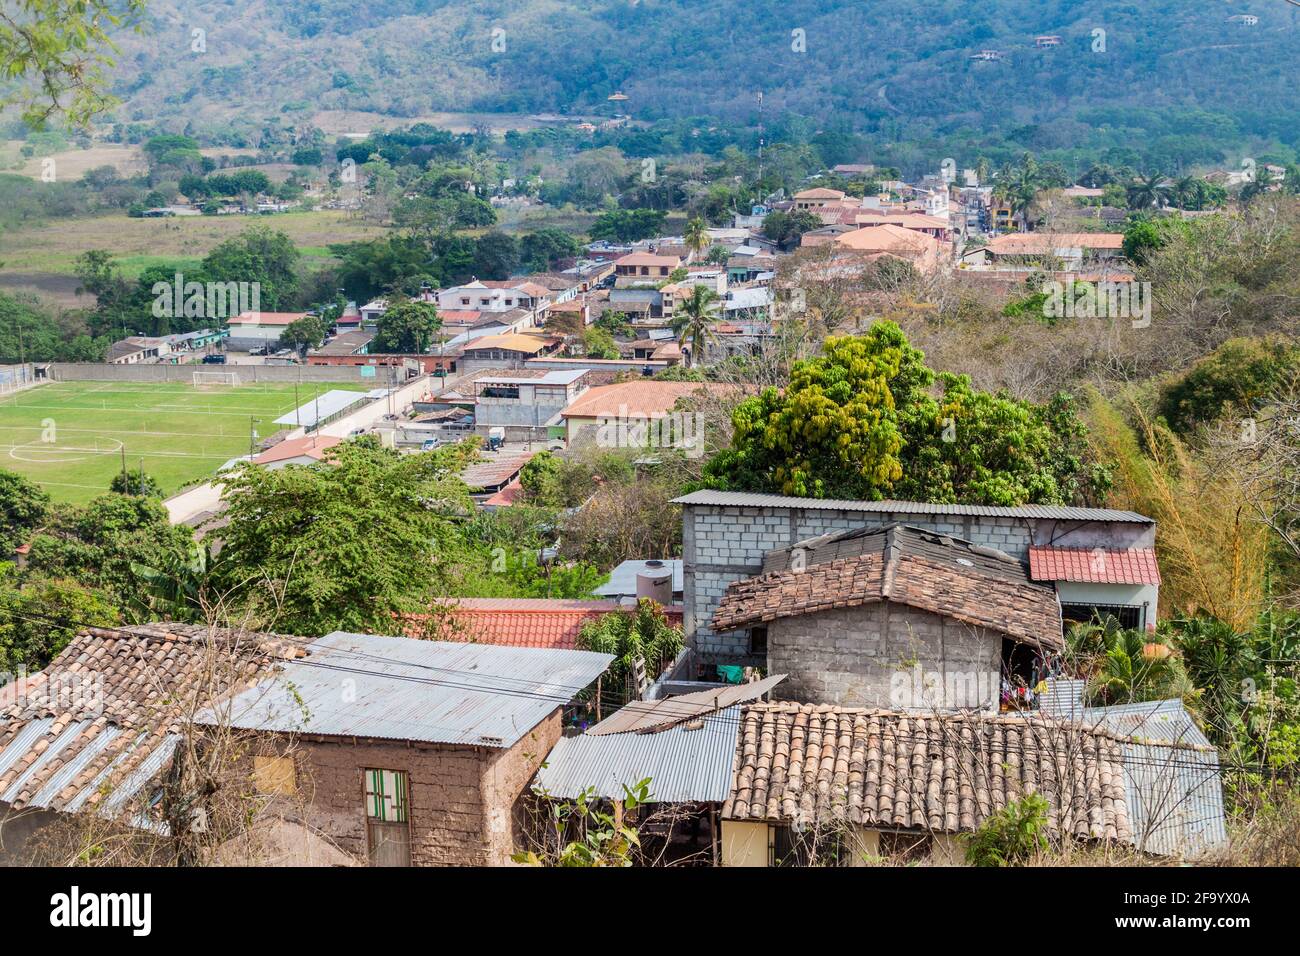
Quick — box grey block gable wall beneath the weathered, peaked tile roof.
[767,601,1002,711]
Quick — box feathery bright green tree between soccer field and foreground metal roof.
[213,438,473,635]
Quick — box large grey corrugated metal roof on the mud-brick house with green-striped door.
[209,631,614,748]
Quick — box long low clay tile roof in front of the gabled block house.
[723,704,1132,842]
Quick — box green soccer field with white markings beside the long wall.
[0,382,365,503]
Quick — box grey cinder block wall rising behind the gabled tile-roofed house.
[681,505,1031,666]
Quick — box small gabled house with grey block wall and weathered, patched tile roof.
[712,524,1065,711]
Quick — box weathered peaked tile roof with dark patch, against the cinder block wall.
[712,524,1063,649]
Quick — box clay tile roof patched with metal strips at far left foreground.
[0,623,308,812]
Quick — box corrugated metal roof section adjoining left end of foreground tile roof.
[533,705,740,803]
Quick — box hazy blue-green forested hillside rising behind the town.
[104,0,1300,163]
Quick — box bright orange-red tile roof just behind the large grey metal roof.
[418,597,681,650]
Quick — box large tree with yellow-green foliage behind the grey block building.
[705,321,1109,505]
